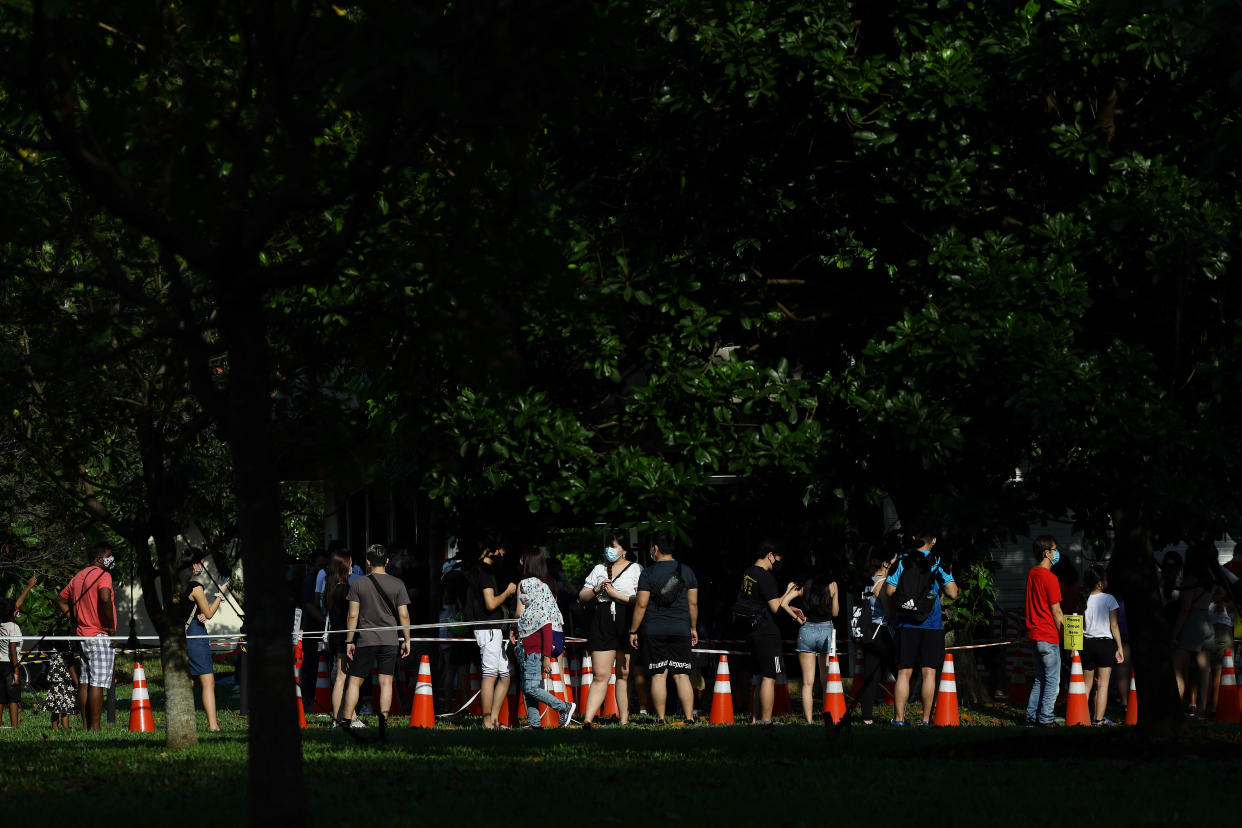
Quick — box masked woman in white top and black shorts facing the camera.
[578,533,642,730]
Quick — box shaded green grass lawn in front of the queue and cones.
[0,655,1242,828]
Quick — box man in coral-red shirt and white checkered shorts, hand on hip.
[56,545,117,730]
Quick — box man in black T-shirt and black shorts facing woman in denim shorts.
[733,540,806,725]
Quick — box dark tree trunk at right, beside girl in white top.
[1113,508,1185,739]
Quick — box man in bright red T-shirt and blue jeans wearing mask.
[1026,535,1066,727]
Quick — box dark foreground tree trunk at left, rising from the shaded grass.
[219,286,309,826]
